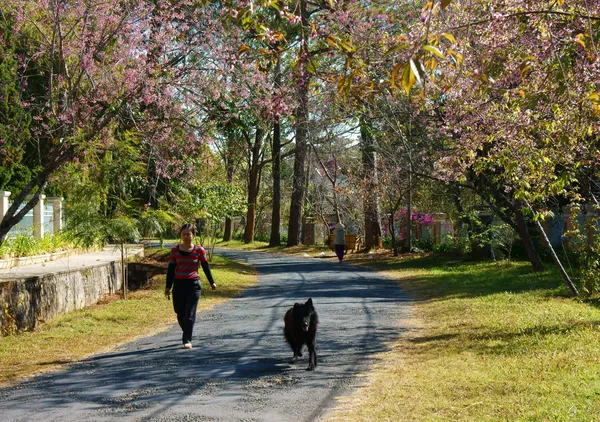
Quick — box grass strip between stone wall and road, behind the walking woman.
[0,249,257,385]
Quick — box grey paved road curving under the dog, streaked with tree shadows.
[0,250,410,422]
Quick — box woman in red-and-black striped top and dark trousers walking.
[165,224,217,349]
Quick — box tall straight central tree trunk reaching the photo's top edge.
[287,0,310,246]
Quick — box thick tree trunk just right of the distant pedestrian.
[360,116,381,249]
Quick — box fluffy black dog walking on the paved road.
[283,298,319,371]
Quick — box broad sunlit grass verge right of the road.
[327,252,600,422]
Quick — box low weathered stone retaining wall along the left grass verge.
[0,261,122,334]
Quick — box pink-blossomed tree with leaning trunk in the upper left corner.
[0,0,214,242]
